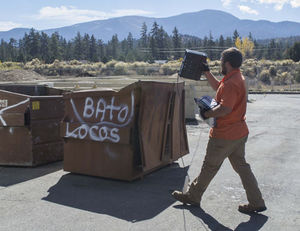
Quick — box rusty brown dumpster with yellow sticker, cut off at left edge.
[0,85,64,166]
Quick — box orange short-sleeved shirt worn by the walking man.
[210,70,249,140]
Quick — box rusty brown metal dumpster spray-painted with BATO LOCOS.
[62,81,189,181]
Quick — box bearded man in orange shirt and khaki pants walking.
[172,48,267,213]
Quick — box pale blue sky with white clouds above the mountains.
[0,0,300,31]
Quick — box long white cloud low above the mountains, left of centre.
[35,6,151,23]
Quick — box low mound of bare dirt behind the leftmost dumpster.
[0,69,46,82]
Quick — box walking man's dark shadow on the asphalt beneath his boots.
[174,205,268,231]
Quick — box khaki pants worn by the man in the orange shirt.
[188,136,265,206]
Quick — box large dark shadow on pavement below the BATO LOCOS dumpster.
[43,164,188,222]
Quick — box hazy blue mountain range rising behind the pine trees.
[0,10,300,42]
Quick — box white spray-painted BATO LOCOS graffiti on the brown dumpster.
[65,92,135,143]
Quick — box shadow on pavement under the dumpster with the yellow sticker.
[0,161,63,187]
